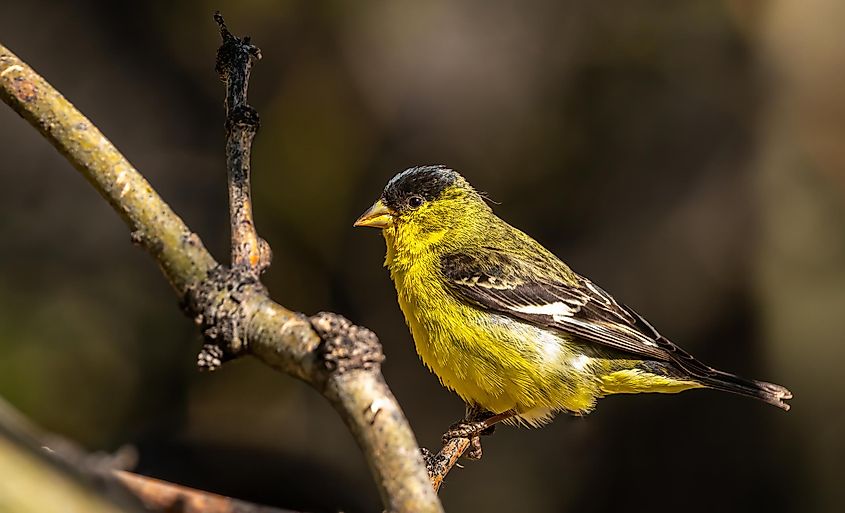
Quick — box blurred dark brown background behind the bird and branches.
[0,0,845,513]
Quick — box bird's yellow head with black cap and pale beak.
[355,166,490,252]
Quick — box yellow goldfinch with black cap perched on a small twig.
[355,166,792,434]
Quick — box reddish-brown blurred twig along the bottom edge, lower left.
[114,470,296,513]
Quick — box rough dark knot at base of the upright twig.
[185,266,267,371]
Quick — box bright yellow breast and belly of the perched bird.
[391,256,601,416]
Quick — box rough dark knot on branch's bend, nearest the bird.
[310,312,384,374]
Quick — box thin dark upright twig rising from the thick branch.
[214,12,270,273]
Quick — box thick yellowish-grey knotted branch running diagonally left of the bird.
[0,20,442,513]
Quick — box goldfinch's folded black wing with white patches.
[441,248,698,366]
